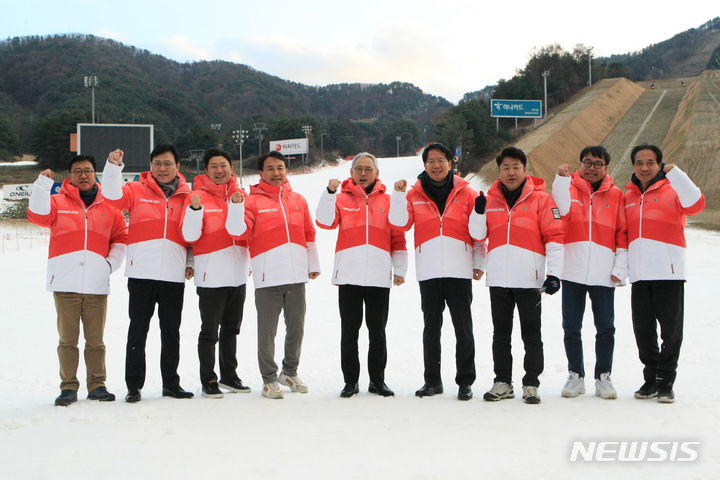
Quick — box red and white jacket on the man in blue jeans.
[552,171,627,287]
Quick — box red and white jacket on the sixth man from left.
[388,175,484,281]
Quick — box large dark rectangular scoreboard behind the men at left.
[77,123,154,172]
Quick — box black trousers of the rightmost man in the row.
[630,280,685,388]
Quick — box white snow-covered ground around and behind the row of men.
[0,157,720,479]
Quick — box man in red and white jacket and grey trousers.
[227,151,320,398]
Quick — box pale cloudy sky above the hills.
[0,0,720,102]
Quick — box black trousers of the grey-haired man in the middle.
[338,285,390,384]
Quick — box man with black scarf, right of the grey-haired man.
[389,143,482,400]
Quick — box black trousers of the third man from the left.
[197,285,245,384]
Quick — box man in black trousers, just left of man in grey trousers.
[181,148,250,398]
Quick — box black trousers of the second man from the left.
[125,278,185,389]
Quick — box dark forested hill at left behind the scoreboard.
[0,34,451,155]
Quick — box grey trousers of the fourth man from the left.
[255,283,305,383]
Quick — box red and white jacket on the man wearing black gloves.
[470,175,563,288]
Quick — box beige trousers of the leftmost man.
[53,292,107,392]
